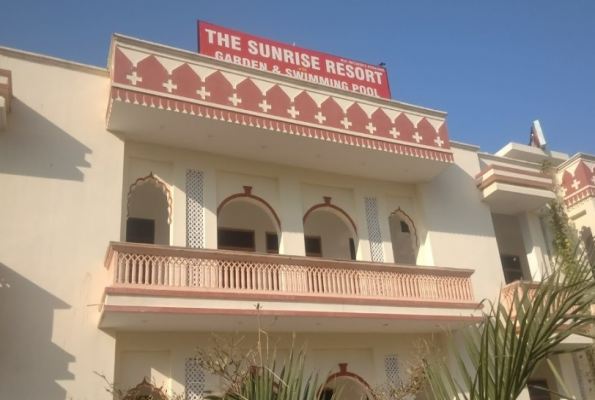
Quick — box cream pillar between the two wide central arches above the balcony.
[279,175,306,256]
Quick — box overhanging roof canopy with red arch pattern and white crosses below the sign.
[106,35,453,182]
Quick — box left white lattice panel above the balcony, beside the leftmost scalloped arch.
[186,171,205,248]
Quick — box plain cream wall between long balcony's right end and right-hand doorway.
[419,148,504,300]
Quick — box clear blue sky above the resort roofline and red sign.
[0,0,595,155]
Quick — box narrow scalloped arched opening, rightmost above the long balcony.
[388,208,419,265]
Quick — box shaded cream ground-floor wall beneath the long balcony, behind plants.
[115,332,434,399]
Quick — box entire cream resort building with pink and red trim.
[0,28,595,400]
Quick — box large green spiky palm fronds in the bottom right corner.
[424,245,595,400]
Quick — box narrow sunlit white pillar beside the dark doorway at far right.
[518,213,549,281]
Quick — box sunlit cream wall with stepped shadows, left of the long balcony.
[0,56,124,399]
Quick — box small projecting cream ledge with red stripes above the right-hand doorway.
[475,164,556,214]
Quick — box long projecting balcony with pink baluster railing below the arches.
[100,243,480,332]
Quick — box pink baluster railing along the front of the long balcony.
[114,250,473,301]
